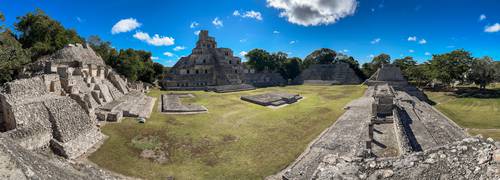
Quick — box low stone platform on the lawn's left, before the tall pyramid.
[161,93,208,113]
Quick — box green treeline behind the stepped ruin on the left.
[0,9,164,84]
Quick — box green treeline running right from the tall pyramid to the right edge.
[245,48,500,89]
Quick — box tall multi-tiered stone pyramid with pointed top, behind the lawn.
[162,30,286,92]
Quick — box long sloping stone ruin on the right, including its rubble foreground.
[276,66,500,179]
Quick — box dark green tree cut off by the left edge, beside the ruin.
[0,30,30,84]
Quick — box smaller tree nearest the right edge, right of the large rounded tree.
[467,56,495,90]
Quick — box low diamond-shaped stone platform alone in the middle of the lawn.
[241,92,302,106]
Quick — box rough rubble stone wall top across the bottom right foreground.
[311,137,500,180]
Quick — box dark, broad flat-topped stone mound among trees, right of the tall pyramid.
[294,62,362,85]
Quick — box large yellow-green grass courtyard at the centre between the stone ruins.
[89,85,366,179]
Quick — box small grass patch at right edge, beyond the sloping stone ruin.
[426,84,500,140]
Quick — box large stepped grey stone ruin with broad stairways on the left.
[0,44,154,159]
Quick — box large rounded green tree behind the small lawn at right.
[429,49,473,85]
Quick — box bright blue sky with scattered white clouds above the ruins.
[0,0,500,66]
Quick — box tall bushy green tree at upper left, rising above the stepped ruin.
[14,9,84,60]
